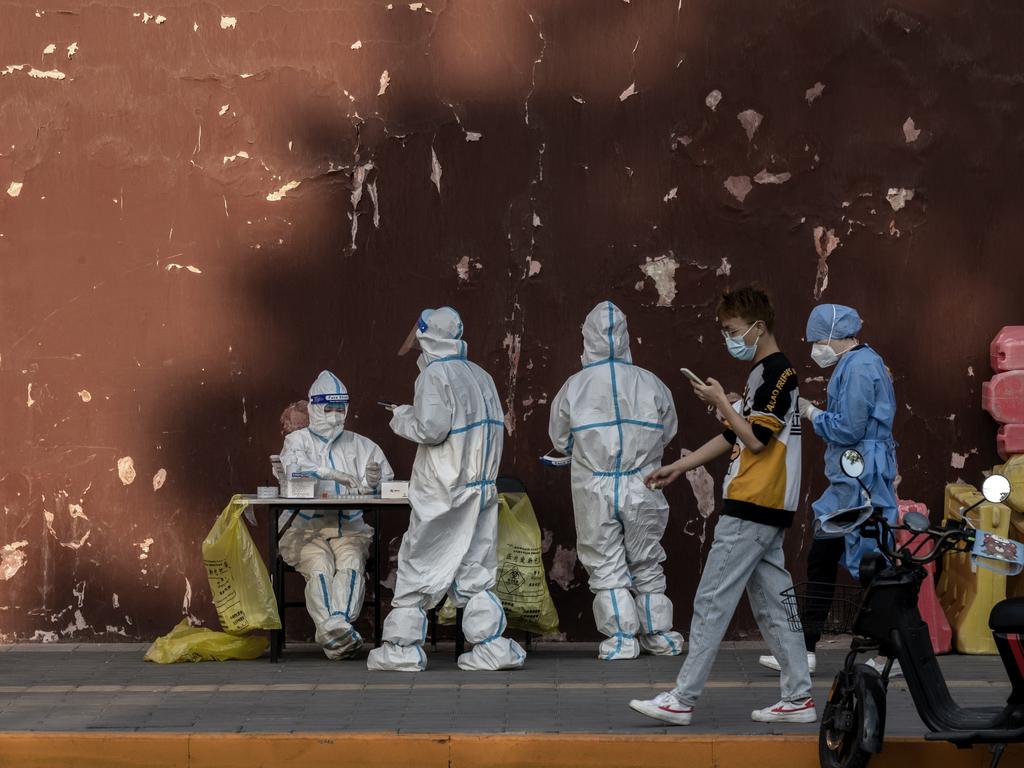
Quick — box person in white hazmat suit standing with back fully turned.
[548,301,683,660]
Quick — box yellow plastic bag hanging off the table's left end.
[203,496,281,635]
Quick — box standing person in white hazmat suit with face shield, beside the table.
[367,307,526,672]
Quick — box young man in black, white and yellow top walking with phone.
[630,286,817,725]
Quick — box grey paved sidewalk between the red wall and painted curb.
[0,642,1009,737]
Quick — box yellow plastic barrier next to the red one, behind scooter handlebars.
[938,483,1011,654]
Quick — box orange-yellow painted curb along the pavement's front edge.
[0,732,1024,768]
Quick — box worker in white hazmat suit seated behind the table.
[280,371,394,658]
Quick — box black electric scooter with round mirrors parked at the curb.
[806,450,1024,768]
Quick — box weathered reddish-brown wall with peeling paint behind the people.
[0,0,1024,641]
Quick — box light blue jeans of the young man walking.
[672,515,811,707]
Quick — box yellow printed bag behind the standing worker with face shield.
[437,494,558,635]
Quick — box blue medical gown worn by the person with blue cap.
[811,345,897,578]
